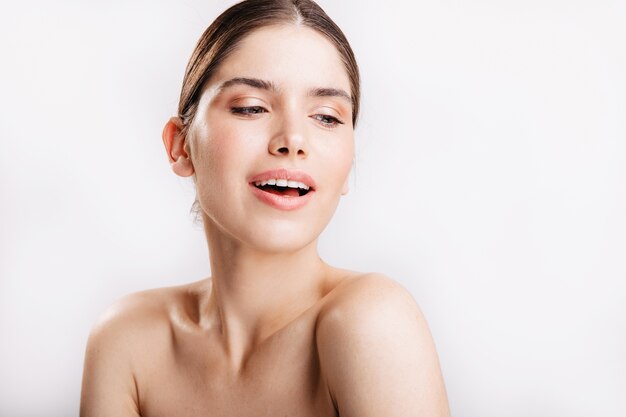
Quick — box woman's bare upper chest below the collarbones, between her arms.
[138,312,337,417]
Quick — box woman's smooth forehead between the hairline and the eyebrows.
[210,24,350,91]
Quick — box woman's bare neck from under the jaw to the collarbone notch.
[204,218,327,366]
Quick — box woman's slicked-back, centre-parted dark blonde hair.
[178,0,360,134]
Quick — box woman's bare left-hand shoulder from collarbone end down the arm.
[80,287,200,417]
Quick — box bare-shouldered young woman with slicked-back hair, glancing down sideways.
[81,0,449,417]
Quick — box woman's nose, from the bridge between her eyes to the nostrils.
[268,109,309,159]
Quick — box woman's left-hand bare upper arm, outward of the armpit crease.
[80,295,149,417]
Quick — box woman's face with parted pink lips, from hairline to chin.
[187,25,354,251]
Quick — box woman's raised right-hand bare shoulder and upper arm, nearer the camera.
[317,276,449,417]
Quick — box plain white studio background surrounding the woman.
[0,0,626,417]
